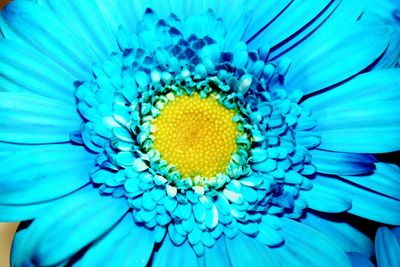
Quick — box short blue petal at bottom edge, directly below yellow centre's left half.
[152,239,199,267]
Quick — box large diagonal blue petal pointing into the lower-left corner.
[10,187,128,266]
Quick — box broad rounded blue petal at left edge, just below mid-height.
[0,143,94,204]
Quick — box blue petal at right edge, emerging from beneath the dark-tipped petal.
[341,162,400,200]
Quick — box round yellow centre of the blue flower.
[152,93,238,178]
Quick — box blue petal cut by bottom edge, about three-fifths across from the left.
[225,234,282,267]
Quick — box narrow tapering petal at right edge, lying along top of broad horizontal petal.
[302,69,400,112]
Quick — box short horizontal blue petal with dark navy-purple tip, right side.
[310,149,375,175]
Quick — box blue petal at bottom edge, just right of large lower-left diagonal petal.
[80,214,154,267]
